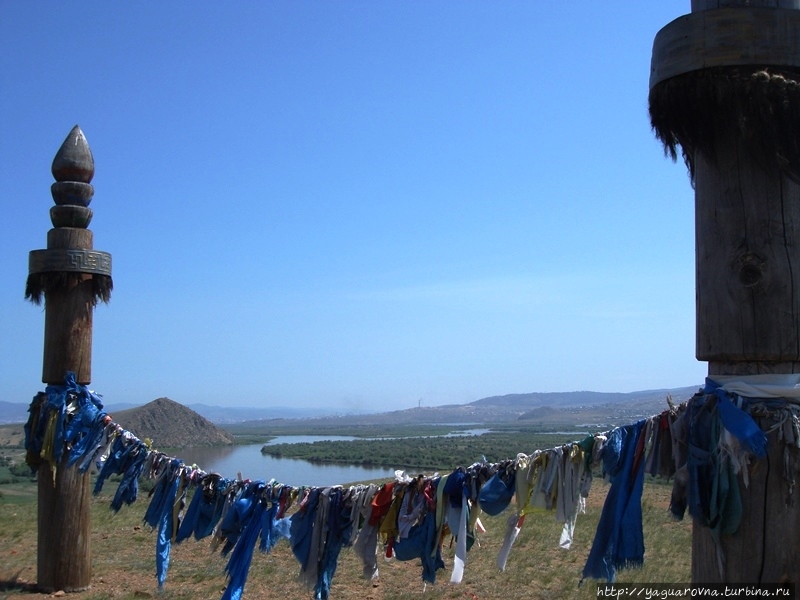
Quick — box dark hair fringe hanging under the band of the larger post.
[649,67,800,183]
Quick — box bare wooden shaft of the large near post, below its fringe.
[692,140,800,583]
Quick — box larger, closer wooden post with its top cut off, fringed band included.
[650,0,800,583]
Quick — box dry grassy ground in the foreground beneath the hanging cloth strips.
[0,474,691,600]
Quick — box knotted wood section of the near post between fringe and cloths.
[695,139,800,363]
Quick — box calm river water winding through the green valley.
[175,429,488,487]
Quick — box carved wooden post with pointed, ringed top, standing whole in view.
[25,125,112,592]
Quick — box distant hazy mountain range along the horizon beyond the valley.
[0,385,700,428]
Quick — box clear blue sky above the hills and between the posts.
[0,0,706,411]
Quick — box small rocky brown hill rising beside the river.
[113,398,233,449]
